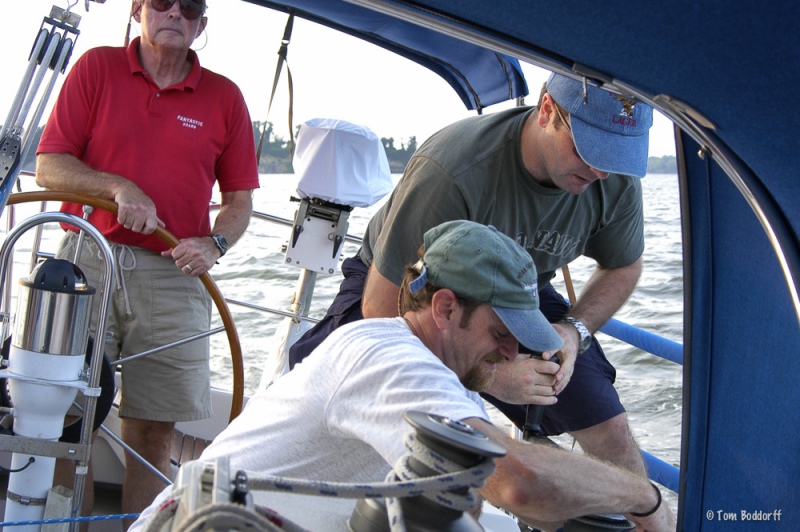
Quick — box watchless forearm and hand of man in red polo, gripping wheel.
[36,153,164,235]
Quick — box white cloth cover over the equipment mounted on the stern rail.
[292,118,392,207]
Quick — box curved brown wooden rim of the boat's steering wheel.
[8,190,244,423]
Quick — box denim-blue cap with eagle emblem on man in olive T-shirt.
[547,74,653,177]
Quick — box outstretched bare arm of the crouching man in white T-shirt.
[465,418,675,531]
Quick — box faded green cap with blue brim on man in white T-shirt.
[410,220,563,351]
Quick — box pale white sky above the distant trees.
[0,0,675,156]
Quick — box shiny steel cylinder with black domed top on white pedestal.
[12,259,95,357]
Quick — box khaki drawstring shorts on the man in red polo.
[56,231,212,422]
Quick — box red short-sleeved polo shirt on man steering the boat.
[37,38,258,252]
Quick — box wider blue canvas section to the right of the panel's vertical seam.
[704,167,800,530]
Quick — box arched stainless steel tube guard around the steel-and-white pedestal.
[0,213,114,532]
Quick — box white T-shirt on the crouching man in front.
[201,318,489,482]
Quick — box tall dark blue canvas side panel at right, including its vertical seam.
[682,133,800,530]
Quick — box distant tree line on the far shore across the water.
[14,121,678,174]
